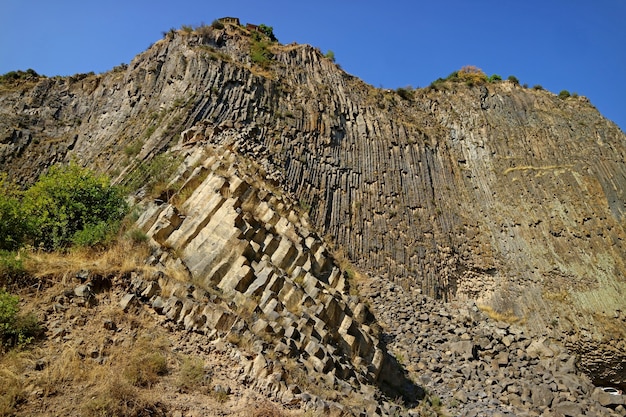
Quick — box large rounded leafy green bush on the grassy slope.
[22,162,127,250]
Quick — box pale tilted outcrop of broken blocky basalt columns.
[129,145,418,402]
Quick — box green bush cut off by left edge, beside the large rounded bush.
[0,173,27,250]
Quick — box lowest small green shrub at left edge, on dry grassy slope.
[0,288,40,351]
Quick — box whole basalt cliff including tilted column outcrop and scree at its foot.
[0,23,626,415]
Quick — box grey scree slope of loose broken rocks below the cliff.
[361,277,625,416]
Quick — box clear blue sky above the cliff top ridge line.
[0,0,626,131]
